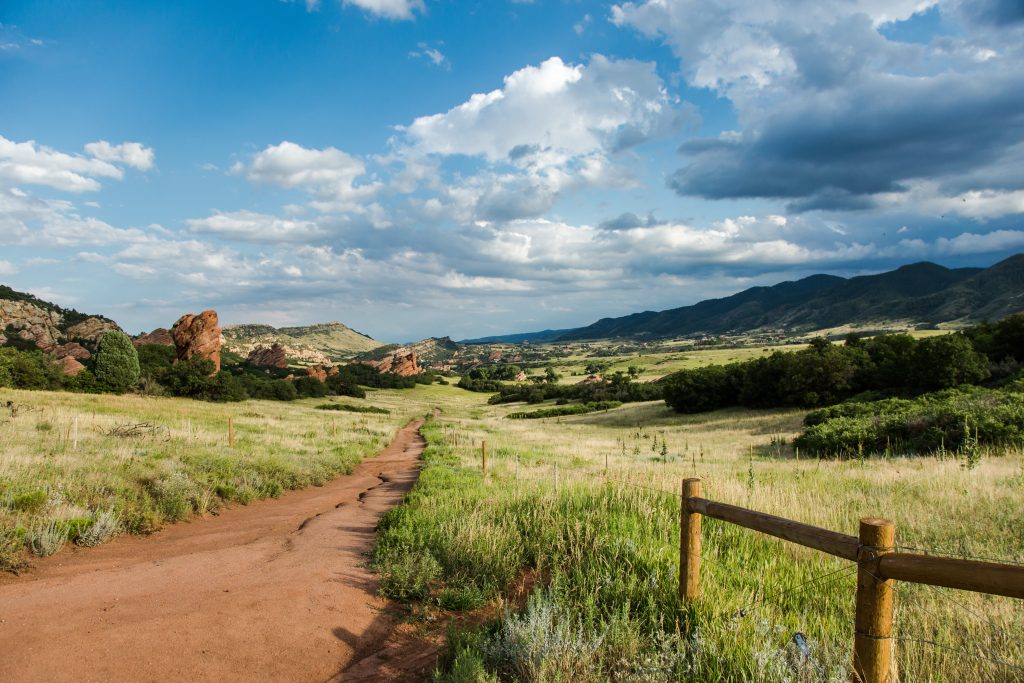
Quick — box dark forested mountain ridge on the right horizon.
[481,254,1024,343]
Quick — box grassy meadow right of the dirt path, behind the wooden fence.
[375,395,1024,681]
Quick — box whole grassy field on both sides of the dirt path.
[0,382,1024,682]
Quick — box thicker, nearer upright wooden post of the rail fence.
[853,517,896,683]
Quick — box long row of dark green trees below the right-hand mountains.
[664,315,1024,413]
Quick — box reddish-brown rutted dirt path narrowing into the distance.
[0,422,429,683]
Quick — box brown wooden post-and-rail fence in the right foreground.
[679,479,1024,683]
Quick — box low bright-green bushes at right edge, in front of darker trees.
[794,380,1024,460]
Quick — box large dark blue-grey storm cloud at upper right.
[669,72,1024,209]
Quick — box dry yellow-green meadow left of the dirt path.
[0,387,464,570]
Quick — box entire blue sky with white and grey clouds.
[0,0,1024,341]
